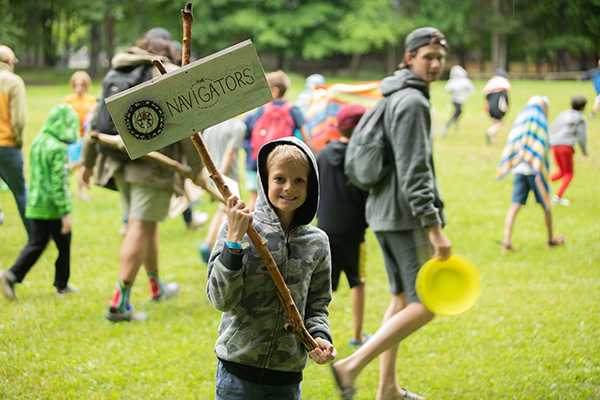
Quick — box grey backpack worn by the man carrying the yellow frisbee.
[344,97,393,191]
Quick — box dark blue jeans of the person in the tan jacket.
[0,147,31,237]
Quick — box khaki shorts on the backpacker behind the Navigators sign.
[115,178,173,222]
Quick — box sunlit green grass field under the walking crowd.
[0,69,600,400]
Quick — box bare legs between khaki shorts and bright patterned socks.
[119,219,158,282]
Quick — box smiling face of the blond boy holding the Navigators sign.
[268,162,308,218]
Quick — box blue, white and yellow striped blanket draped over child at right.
[496,96,550,210]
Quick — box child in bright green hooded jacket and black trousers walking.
[0,104,79,300]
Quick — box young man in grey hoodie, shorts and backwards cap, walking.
[333,27,452,399]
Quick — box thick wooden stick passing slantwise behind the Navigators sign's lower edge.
[90,133,227,204]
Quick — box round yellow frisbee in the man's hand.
[416,255,481,316]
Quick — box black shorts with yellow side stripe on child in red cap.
[329,242,365,290]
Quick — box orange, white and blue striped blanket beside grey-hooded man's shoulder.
[306,81,382,152]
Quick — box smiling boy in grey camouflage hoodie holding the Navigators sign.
[207,137,337,400]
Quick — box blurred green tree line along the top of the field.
[0,0,600,76]
